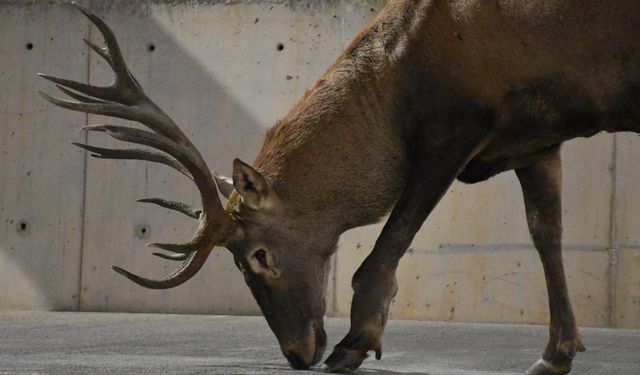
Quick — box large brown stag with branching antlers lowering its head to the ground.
[40,0,640,375]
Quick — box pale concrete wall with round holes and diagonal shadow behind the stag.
[0,0,640,327]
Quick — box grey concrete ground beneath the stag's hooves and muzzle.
[0,312,640,375]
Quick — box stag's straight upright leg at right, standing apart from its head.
[516,147,585,375]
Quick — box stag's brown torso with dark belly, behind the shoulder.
[408,0,640,182]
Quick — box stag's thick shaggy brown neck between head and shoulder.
[255,1,440,230]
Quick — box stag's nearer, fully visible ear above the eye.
[233,159,269,210]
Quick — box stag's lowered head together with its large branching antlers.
[41,5,337,368]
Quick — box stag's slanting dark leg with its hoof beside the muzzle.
[324,113,487,372]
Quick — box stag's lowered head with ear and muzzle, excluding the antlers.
[218,159,337,368]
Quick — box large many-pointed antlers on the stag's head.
[38,3,231,289]
